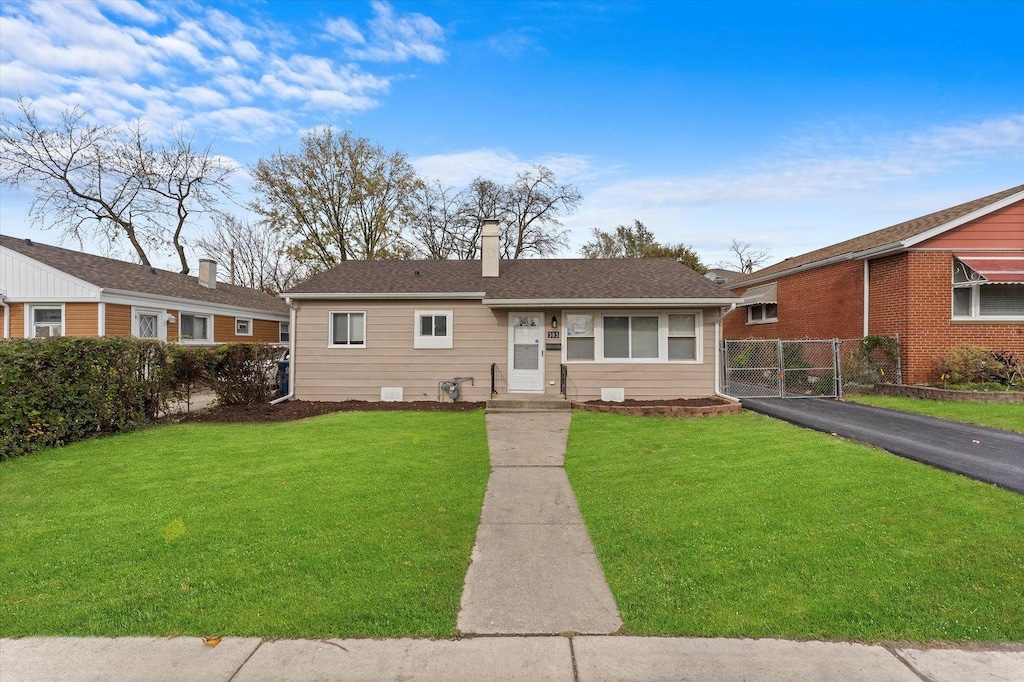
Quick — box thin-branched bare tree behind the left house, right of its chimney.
[196,214,306,294]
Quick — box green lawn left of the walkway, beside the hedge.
[0,411,489,638]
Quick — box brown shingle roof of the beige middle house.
[286,258,734,300]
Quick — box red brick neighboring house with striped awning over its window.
[723,185,1024,383]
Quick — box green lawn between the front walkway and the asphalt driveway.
[566,412,1024,641]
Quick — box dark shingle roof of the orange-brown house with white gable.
[0,236,288,314]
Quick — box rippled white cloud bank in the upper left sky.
[0,0,443,139]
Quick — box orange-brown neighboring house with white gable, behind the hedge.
[0,236,289,344]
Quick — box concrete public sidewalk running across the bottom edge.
[0,636,1024,682]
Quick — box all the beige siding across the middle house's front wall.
[294,301,719,401]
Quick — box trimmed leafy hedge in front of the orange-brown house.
[0,337,273,460]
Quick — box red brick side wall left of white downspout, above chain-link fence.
[722,260,864,339]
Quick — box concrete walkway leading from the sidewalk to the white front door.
[457,412,623,635]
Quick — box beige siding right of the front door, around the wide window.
[561,308,719,400]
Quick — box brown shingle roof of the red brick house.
[729,184,1024,287]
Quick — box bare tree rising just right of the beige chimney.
[501,166,583,258]
